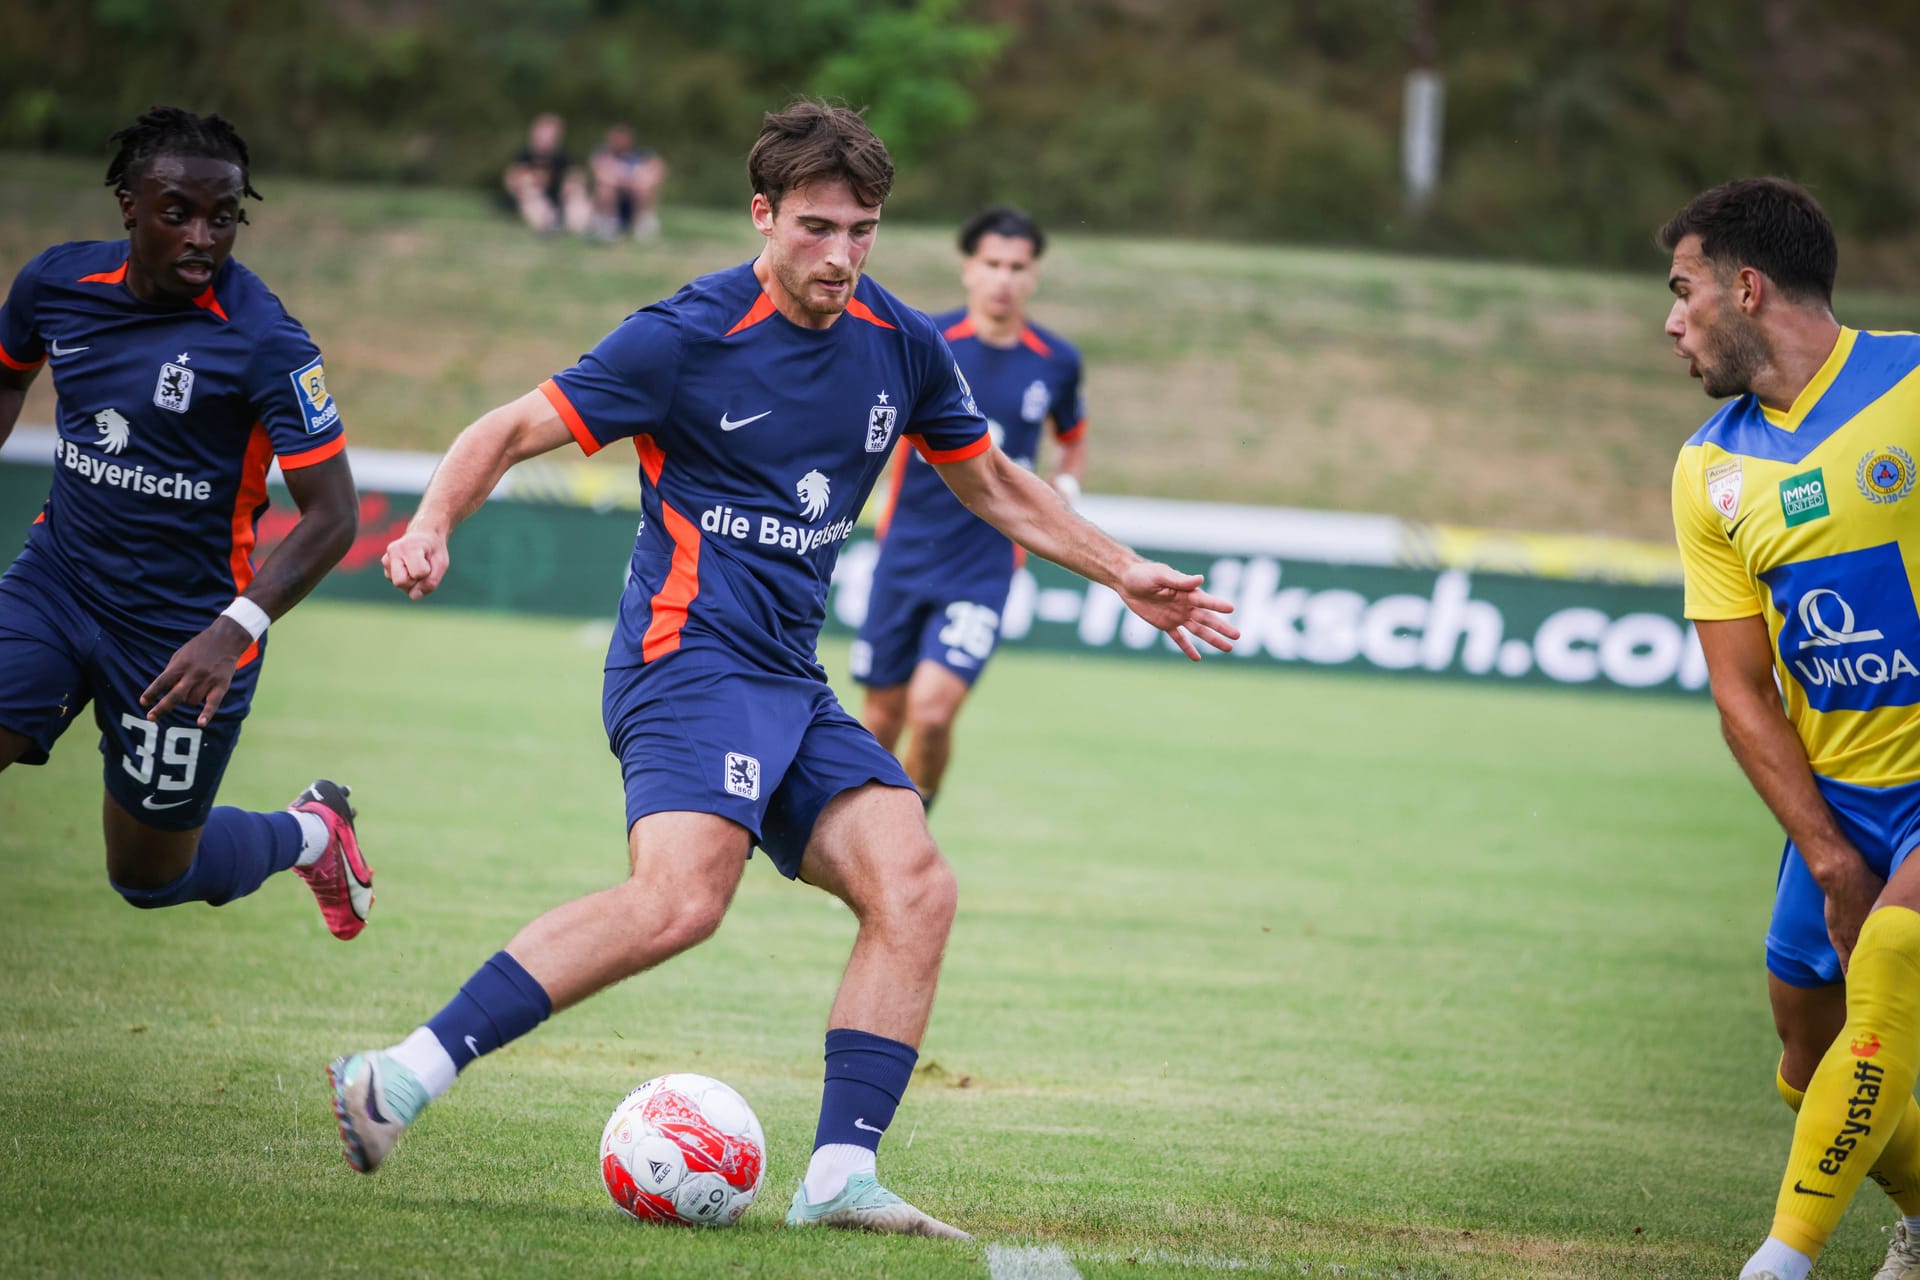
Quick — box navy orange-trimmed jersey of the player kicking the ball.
[541,263,991,679]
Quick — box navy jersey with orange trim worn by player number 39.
[0,240,346,639]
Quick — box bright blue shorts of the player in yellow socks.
[1766,775,1920,986]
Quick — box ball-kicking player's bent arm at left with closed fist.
[380,391,572,601]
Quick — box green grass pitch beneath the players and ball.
[0,604,1893,1278]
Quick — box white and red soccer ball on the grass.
[601,1071,766,1226]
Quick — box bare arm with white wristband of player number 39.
[140,453,359,727]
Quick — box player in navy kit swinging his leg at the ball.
[328,102,1236,1238]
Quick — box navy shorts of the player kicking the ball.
[601,651,914,879]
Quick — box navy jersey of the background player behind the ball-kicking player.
[881,309,1087,583]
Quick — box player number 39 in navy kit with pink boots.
[0,107,372,938]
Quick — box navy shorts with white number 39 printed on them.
[0,558,261,831]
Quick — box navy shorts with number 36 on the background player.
[847,572,1014,689]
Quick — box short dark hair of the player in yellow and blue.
[1659,178,1839,303]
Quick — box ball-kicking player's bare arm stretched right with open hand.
[935,449,1240,662]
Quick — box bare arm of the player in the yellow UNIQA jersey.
[1695,614,1882,965]
